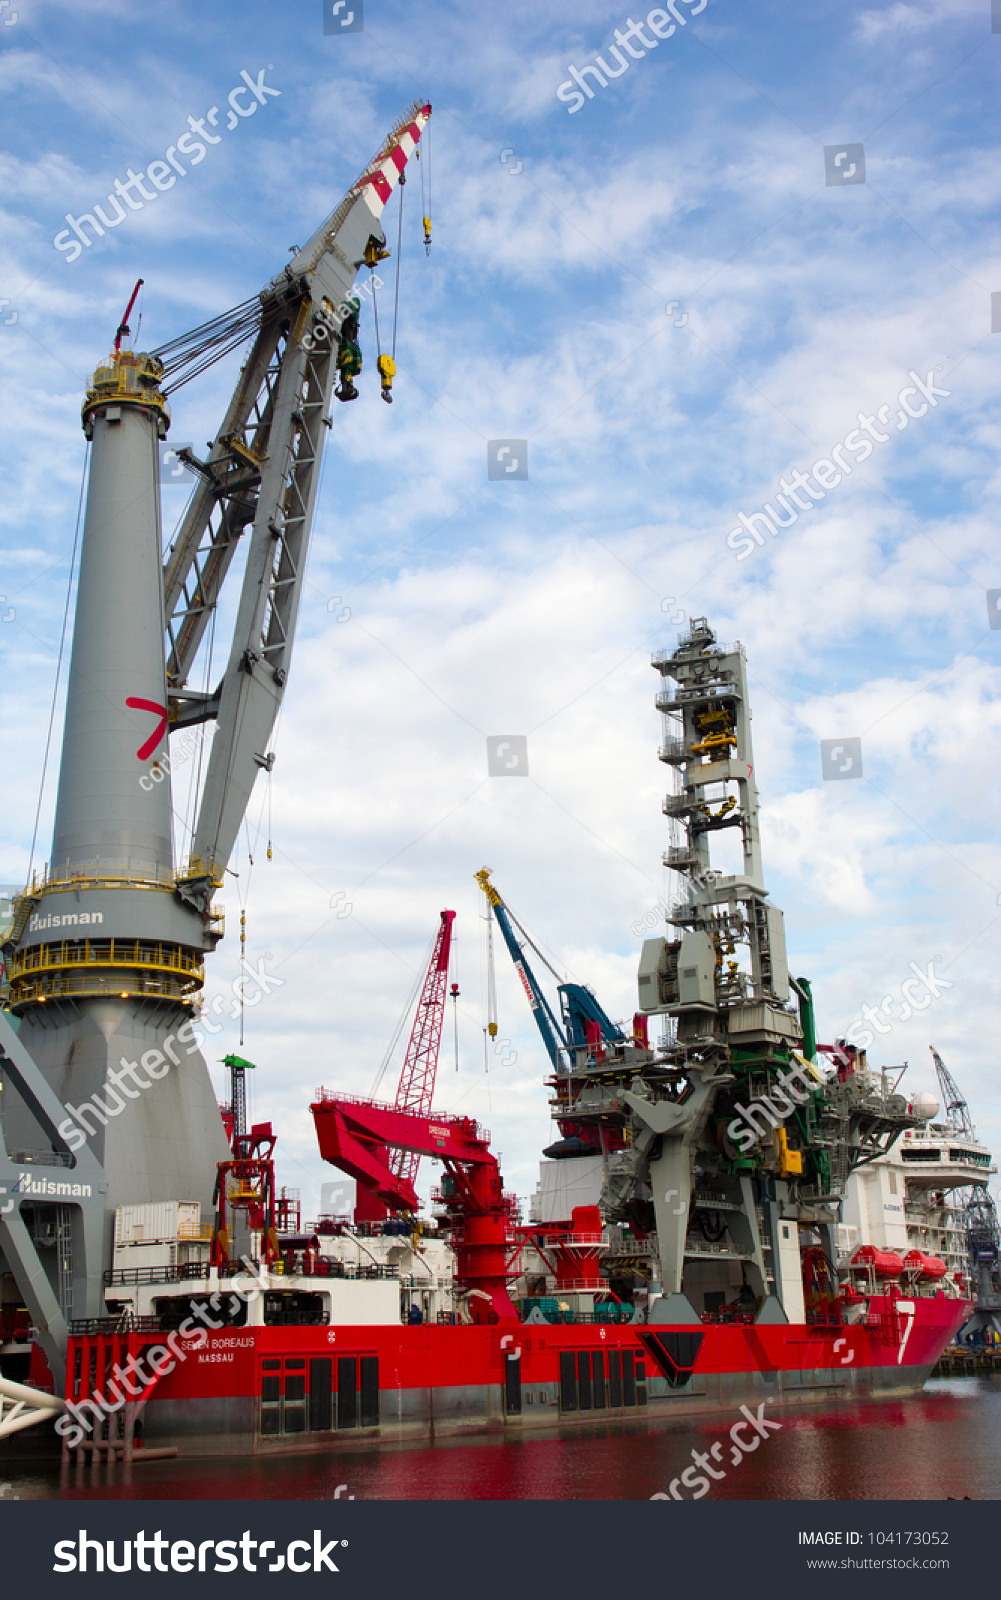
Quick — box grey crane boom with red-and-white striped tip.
[163,101,430,909]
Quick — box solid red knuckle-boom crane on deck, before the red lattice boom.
[310,1088,518,1323]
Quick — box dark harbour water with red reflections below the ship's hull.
[0,1378,1001,1501]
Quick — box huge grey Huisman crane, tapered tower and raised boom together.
[0,102,430,1370]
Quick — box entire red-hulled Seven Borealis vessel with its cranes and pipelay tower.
[0,118,969,1459]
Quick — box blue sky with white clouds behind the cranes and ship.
[0,0,1001,1214]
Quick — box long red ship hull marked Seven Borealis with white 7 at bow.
[54,1296,969,1458]
